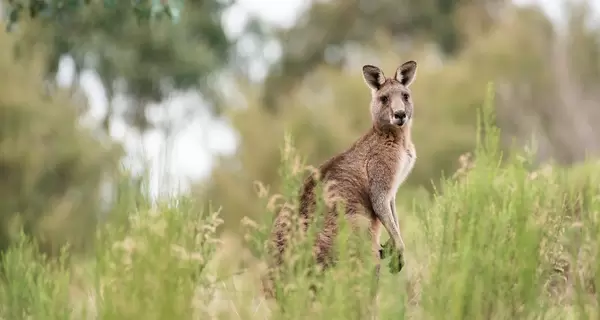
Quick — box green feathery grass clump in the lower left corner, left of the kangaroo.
[0,190,227,319]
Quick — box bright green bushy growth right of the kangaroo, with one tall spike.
[420,85,600,319]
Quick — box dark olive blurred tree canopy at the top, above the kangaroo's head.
[264,0,510,112]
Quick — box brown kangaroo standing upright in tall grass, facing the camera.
[263,60,417,297]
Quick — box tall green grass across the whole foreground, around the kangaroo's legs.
[0,86,600,320]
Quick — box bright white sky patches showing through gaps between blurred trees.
[58,0,600,197]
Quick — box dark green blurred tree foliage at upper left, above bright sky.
[7,0,233,132]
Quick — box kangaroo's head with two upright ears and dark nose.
[363,60,417,128]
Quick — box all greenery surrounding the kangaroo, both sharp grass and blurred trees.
[0,0,600,320]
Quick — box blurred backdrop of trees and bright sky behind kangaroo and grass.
[0,0,600,255]
